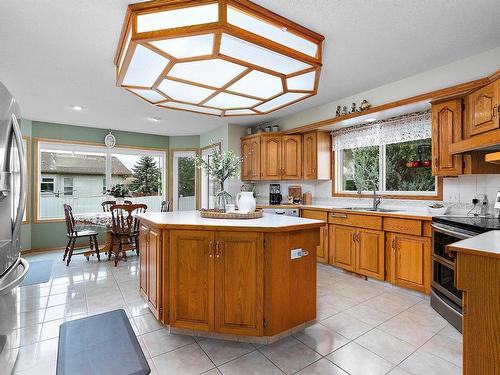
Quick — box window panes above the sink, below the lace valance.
[336,138,437,196]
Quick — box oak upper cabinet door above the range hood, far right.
[466,80,500,136]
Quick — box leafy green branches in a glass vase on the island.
[195,145,241,212]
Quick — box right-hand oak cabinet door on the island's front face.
[215,232,264,336]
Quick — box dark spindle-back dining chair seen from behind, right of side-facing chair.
[108,204,148,266]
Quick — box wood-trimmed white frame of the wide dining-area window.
[33,138,169,223]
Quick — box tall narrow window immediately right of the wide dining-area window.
[172,150,197,211]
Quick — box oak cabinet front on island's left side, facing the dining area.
[139,226,162,320]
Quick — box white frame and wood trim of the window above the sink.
[332,142,443,200]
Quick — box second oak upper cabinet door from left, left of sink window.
[260,134,282,180]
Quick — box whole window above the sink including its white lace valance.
[332,111,440,199]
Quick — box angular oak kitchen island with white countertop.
[138,211,325,343]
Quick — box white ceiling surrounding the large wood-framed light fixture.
[0,0,500,135]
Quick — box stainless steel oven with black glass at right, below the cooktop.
[431,223,478,331]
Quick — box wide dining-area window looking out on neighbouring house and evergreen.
[36,141,166,220]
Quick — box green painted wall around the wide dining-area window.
[25,120,174,249]
